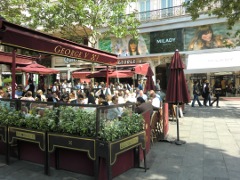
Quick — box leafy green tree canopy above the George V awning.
[0,0,140,47]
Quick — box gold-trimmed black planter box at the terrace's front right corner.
[96,131,146,179]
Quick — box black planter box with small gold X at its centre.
[48,133,96,176]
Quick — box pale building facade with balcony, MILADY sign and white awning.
[98,0,240,96]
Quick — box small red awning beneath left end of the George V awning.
[0,52,33,65]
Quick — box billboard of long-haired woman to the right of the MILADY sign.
[184,23,240,51]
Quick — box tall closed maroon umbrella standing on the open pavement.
[166,50,190,145]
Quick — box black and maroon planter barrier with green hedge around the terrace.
[0,99,153,179]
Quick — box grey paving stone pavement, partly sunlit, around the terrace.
[0,100,240,180]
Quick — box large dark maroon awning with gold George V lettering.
[0,20,117,65]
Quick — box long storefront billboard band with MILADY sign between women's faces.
[99,23,240,56]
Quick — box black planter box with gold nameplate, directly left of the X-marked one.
[7,127,49,174]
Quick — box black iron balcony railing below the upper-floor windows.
[136,6,186,22]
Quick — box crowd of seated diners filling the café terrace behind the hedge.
[0,80,162,119]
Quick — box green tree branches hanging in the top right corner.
[183,0,240,42]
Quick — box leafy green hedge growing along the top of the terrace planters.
[0,106,144,142]
